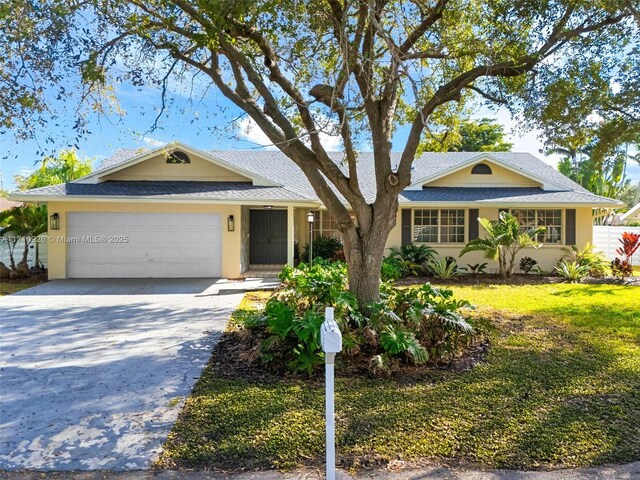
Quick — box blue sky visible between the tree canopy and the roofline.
[0,82,640,190]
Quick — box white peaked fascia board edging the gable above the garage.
[71,142,282,187]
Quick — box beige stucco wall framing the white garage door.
[48,202,242,279]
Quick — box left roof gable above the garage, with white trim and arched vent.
[74,143,279,186]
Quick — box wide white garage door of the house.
[67,212,222,278]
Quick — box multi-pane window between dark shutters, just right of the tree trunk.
[413,209,465,243]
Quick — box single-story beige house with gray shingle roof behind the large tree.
[12,143,621,279]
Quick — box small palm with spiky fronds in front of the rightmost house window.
[460,212,546,278]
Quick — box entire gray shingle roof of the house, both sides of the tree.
[20,149,616,205]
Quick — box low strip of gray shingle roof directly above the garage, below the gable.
[16,181,308,202]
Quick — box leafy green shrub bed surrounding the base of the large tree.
[237,260,487,374]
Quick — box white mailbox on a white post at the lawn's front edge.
[320,307,342,480]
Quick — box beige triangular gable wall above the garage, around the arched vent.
[102,155,250,182]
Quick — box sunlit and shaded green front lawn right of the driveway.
[159,284,640,470]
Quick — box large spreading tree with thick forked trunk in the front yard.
[0,0,638,305]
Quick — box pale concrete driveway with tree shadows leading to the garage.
[0,279,268,470]
